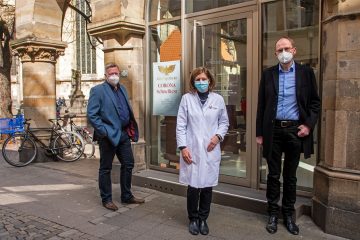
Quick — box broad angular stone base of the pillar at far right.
[312,166,360,239]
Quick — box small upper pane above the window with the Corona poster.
[149,0,181,21]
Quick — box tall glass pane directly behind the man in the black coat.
[260,0,319,188]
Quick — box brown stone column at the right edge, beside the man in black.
[312,0,360,239]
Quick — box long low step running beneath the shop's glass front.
[132,170,311,218]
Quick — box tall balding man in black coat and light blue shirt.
[256,37,320,235]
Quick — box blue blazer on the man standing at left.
[87,82,139,146]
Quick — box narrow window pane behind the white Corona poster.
[149,21,181,169]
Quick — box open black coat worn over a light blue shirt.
[256,62,320,158]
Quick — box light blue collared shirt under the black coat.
[276,61,299,120]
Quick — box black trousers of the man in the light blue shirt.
[266,126,302,217]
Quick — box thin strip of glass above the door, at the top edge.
[185,0,250,13]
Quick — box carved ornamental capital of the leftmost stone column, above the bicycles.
[15,46,64,63]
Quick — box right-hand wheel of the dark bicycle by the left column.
[53,132,84,162]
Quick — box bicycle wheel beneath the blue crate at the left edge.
[2,133,37,167]
